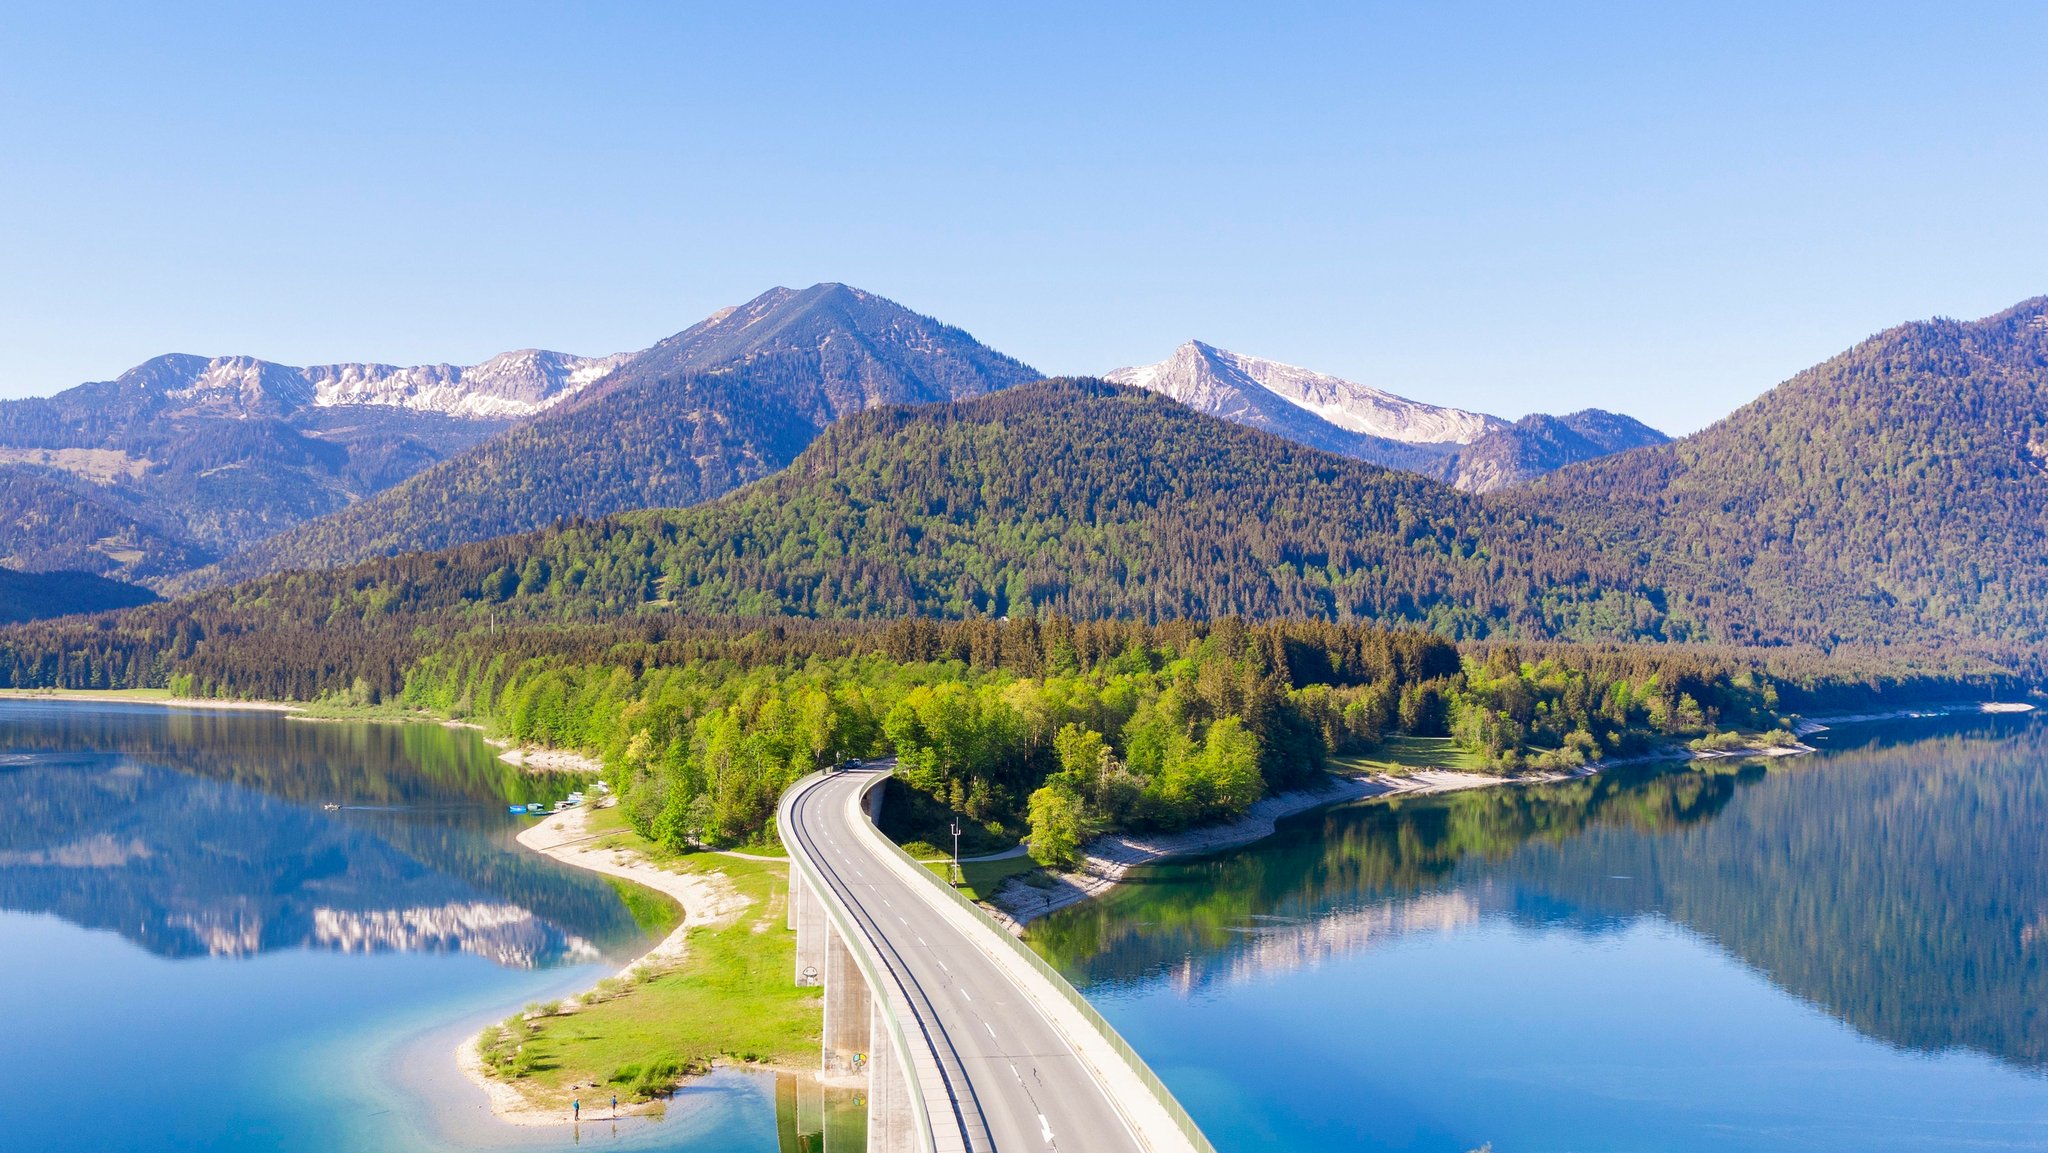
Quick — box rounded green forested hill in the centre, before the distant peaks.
[64,381,1690,639]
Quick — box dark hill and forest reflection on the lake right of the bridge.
[1030,719,2048,1069]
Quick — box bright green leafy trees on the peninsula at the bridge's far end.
[387,618,1458,856]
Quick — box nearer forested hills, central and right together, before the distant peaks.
[16,299,2048,668]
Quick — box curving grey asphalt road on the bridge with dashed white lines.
[782,770,1145,1153]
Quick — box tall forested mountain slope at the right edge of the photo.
[1540,299,2048,647]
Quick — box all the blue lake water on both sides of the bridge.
[0,702,2048,1153]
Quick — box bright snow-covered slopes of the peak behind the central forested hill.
[1104,340,1507,446]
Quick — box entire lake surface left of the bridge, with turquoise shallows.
[0,700,786,1153]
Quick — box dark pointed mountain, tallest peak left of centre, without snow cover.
[190,285,1038,588]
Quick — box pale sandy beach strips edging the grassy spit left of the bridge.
[455,809,748,1124]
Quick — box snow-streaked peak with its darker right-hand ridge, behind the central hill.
[1104,340,1669,492]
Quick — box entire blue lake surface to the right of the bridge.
[1030,719,2048,1153]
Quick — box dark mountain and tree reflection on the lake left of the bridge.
[0,702,647,967]
